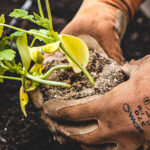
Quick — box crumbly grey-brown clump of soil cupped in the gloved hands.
[40,50,124,100]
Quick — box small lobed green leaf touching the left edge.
[0,49,16,61]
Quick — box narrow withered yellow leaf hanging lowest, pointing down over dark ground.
[20,86,29,117]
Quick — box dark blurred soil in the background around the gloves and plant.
[0,0,150,150]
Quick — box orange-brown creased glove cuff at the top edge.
[99,0,144,21]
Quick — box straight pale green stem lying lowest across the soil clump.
[25,74,70,88]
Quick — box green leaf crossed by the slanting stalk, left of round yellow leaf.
[29,29,55,44]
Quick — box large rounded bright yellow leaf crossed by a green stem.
[60,34,89,73]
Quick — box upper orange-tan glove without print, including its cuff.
[62,0,142,64]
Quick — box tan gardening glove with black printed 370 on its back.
[43,55,150,150]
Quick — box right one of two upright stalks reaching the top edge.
[45,0,53,32]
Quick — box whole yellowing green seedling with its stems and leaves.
[0,0,94,116]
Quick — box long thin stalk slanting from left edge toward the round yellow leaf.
[0,23,53,40]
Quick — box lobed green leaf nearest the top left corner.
[9,9,34,20]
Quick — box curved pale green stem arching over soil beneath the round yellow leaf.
[41,65,71,79]
